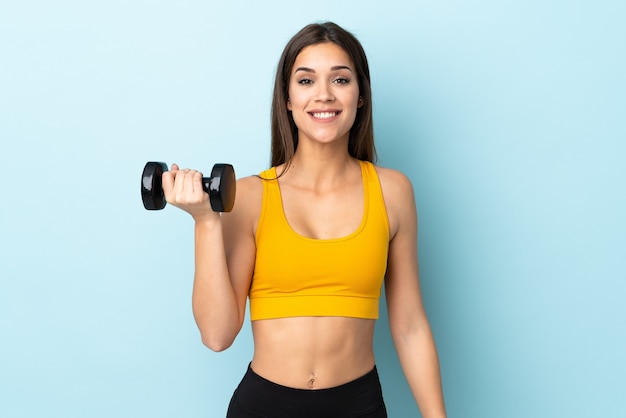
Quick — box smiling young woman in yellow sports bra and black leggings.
[163,23,445,418]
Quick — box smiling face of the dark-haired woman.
[287,42,362,149]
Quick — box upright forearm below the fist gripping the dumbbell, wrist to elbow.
[192,218,244,351]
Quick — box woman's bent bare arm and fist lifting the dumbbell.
[163,165,262,351]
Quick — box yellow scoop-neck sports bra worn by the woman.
[249,161,389,321]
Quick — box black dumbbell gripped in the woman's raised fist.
[141,161,237,212]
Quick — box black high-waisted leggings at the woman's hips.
[226,367,387,418]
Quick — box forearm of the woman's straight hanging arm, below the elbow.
[394,325,446,418]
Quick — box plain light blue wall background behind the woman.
[0,0,626,418]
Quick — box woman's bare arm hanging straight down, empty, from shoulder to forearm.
[381,170,446,418]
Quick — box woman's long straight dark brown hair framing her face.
[271,22,377,166]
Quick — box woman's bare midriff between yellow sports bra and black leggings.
[251,316,375,390]
